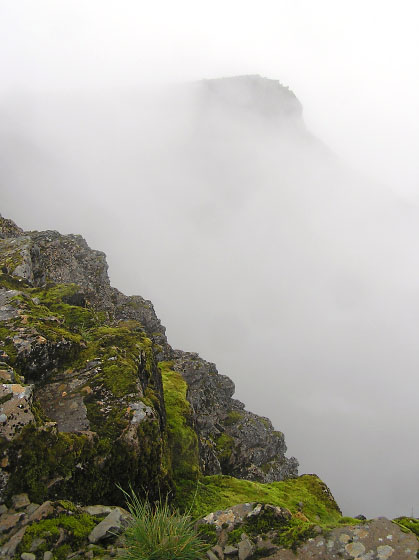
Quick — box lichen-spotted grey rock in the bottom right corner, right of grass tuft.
[198,503,419,560]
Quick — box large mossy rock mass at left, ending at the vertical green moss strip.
[0,219,170,503]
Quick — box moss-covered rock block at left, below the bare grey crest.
[0,260,170,503]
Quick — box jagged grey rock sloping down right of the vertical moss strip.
[173,351,298,482]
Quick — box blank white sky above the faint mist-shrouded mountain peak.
[0,0,419,196]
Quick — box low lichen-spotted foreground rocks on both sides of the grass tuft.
[0,494,419,560]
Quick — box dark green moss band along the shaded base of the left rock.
[6,420,170,505]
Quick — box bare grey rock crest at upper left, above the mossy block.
[0,221,168,357]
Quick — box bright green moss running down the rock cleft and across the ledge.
[159,362,341,550]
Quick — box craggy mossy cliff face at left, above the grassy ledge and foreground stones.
[0,218,298,503]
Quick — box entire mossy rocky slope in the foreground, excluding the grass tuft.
[0,213,419,560]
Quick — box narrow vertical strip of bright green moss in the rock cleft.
[159,362,199,484]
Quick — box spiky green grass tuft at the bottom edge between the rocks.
[121,491,209,560]
